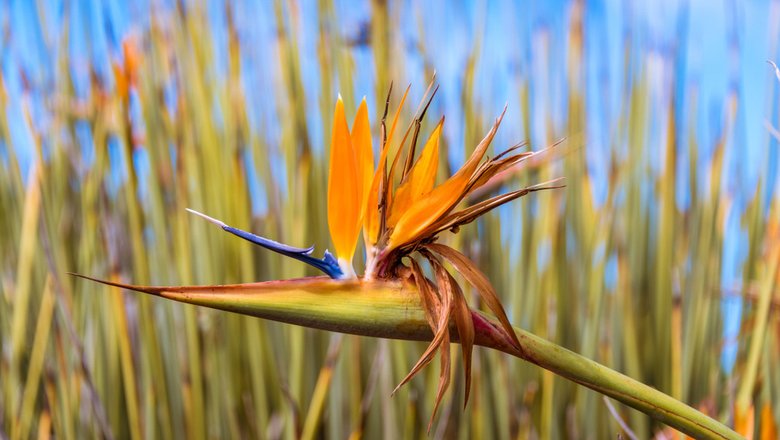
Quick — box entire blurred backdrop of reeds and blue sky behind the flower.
[0,0,780,439]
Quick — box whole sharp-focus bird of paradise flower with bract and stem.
[73,86,736,438]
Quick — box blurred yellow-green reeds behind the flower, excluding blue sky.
[0,0,780,439]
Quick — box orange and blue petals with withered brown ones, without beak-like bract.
[191,87,559,428]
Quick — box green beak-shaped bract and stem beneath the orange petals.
[74,277,741,439]
